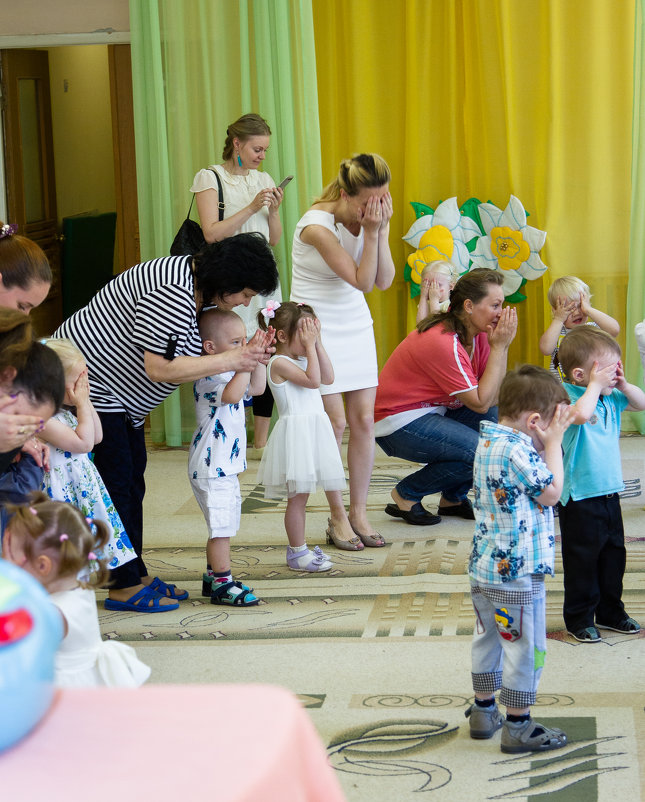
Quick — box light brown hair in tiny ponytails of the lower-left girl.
[7,492,110,587]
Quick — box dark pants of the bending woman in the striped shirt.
[94,412,148,588]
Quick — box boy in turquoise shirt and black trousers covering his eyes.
[559,326,645,643]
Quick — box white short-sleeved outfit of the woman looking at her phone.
[190,164,282,337]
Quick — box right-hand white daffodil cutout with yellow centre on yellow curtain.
[471,195,546,296]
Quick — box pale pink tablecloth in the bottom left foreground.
[0,685,345,802]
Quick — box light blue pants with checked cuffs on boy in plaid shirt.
[470,574,546,708]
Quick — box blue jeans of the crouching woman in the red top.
[376,407,497,501]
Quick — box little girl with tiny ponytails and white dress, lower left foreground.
[2,493,150,688]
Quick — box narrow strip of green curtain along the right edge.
[625,0,645,434]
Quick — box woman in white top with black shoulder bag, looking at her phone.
[190,114,283,456]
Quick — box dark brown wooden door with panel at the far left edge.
[0,50,62,334]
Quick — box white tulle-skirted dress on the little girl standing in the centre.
[258,354,345,498]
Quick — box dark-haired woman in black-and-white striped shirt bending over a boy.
[54,234,278,612]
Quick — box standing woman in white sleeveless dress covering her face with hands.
[291,153,395,550]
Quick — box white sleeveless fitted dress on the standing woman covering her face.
[291,209,378,395]
